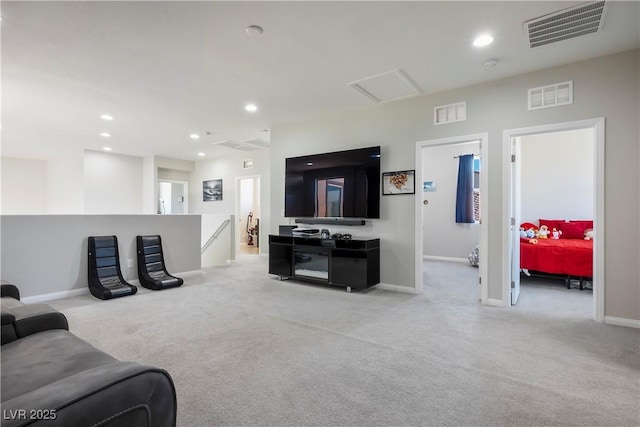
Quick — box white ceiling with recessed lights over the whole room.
[0,1,640,159]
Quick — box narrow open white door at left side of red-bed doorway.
[510,137,522,305]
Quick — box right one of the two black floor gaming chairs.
[136,235,184,291]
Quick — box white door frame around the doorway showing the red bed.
[502,117,605,322]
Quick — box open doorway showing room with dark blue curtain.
[416,134,488,305]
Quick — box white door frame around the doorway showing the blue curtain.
[414,132,491,304]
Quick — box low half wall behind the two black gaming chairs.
[0,215,201,297]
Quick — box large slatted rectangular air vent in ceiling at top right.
[524,1,607,48]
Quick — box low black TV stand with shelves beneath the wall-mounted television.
[269,235,380,292]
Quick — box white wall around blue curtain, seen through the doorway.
[416,142,482,259]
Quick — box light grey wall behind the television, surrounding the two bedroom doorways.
[270,49,640,319]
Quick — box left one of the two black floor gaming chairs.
[89,236,138,299]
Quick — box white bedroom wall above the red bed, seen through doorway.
[520,129,595,224]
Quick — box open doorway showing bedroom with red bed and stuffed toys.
[503,119,604,320]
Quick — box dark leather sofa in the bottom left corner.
[0,285,176,427]
